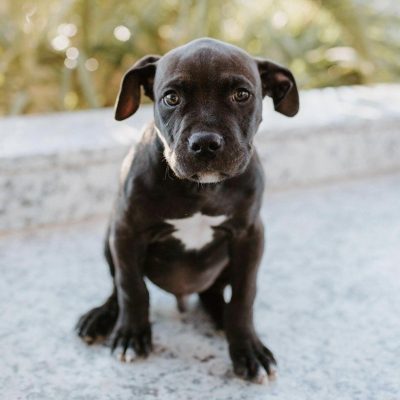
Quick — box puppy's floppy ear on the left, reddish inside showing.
[115,55,161,121]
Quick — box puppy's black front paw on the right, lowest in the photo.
[229,337,277,380]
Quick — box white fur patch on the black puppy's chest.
[165,212,226,250]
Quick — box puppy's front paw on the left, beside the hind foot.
[110,322,153,361]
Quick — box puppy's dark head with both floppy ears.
[115,39,299,183]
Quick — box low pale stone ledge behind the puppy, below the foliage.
[0,85,400,232]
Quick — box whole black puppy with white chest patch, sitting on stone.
[78,39,299,379]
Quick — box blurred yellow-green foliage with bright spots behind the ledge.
[0,0,400,115]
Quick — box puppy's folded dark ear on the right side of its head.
[256,59,299,117]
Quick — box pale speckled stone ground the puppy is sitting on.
[0,175,400,400]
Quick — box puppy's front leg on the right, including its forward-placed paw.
[224,221,276,379]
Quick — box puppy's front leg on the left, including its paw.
[109,230,152,360]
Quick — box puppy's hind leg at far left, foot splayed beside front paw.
[76,227,118,344]
